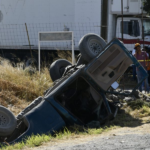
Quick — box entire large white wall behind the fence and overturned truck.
[0,0,101,49]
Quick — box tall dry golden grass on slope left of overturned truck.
[0,61,52,114]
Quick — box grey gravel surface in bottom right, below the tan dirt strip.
[48,134,150,150]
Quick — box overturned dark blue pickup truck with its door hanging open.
[0,34,148,144]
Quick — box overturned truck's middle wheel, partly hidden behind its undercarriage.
[49,59,72,81]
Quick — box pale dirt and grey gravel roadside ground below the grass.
[30,119,150,150]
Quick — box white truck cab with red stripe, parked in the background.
[116,17,150,51]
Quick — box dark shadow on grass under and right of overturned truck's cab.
[56,100,150,133]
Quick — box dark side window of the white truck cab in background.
[120,20,140,37]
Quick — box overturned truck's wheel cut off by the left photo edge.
[0,105,17,136]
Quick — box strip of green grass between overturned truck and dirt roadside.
[0,126,117,150]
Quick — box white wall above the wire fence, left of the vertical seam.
[0,0,74,24]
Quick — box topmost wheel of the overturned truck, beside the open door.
[79,34,106,62]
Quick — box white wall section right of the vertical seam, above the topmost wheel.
[74,0,101,45]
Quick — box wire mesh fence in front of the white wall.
[0,23,100,50]
